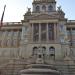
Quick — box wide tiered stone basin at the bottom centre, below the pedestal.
[20,64,60,75]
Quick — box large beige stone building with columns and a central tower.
[0,0,75,74]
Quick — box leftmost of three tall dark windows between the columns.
[33,23,39,42]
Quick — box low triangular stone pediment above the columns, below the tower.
[31,14,58,20]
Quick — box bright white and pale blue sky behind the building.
[0,0,75,22]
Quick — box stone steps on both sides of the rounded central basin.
[0,59,75,75]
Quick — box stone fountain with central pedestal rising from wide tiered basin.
[20,47,60,75]
